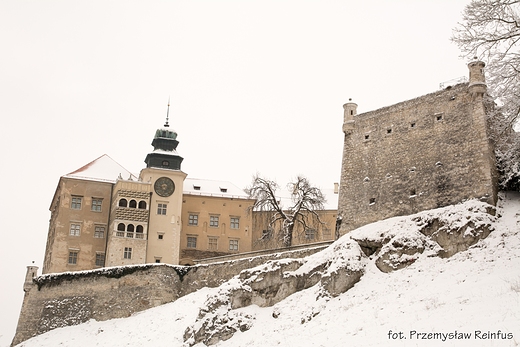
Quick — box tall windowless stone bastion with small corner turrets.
[338,62,497,235]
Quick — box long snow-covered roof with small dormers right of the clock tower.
[183,178,248,199]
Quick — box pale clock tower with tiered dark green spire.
[139,118,186,264]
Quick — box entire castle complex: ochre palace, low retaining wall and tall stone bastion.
[13,61,497,343]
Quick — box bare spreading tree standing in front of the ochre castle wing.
[246,174,326,247]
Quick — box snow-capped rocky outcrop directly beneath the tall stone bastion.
[350,201,495,272]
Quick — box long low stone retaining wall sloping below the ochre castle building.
[12,245,327,346]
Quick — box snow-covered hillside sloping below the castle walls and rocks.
[14,192,520,347]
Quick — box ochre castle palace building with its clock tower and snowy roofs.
[42,119,337,274]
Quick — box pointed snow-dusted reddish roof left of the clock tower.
[62,154,138,183]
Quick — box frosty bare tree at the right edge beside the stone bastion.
[452,0,520,189]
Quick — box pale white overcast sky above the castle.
[0,0,469,344]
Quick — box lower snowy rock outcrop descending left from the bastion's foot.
[184,238,365,346]
